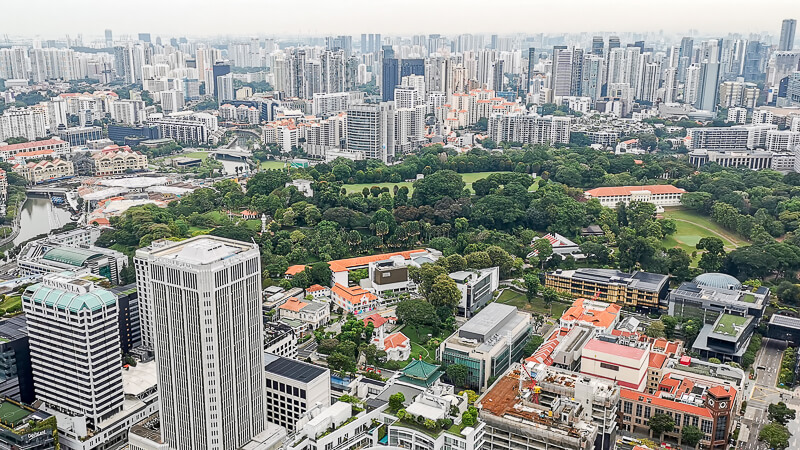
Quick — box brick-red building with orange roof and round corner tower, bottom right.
[620,374,737,450]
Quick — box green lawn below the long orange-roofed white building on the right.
[662,209,747,264]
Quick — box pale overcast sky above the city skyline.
[0,0,800,40]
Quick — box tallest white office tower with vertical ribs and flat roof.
[136,236,266,450]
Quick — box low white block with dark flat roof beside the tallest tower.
[263,353,331,433]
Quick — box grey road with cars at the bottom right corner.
[739,338,800,450]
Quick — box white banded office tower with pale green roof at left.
[22,272,124,436]
